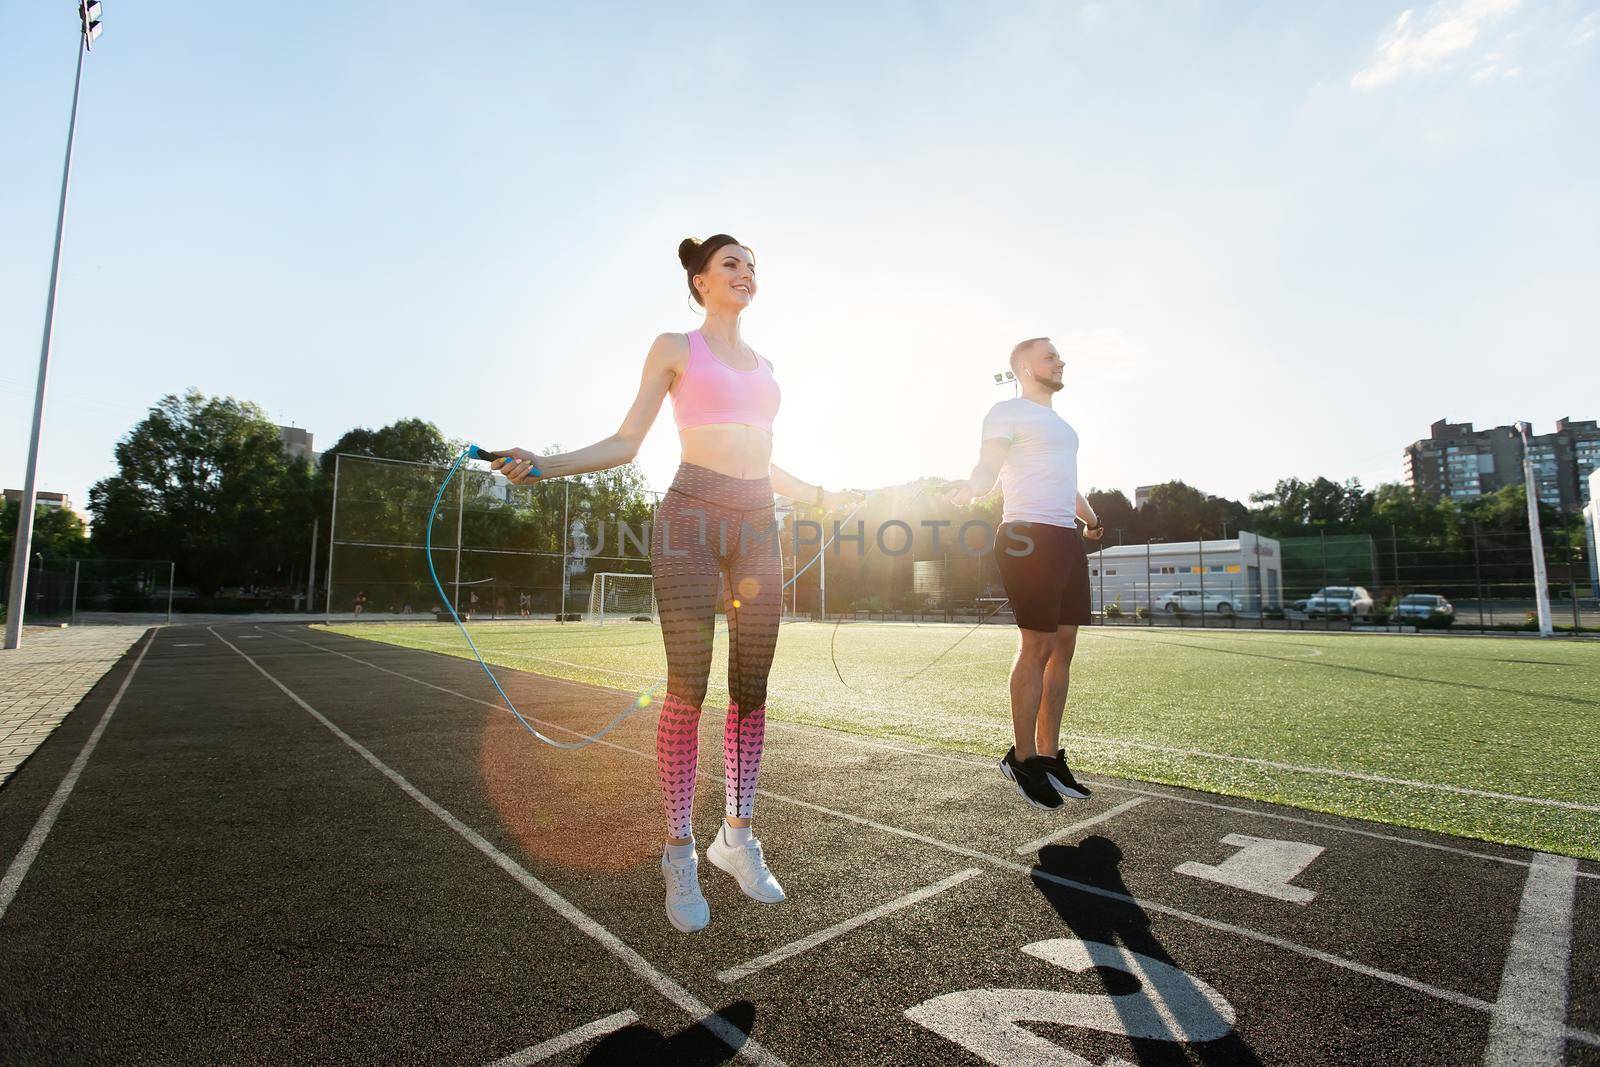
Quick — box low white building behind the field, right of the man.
[1090,531,1283,614]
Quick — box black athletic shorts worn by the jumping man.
[995,523,1091,633]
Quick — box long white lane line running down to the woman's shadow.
[206,627,782,1067]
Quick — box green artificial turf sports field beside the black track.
[326,622,1600,859]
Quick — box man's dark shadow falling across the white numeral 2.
[1034,835,1261,1067]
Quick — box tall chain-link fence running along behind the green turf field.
[323,456,1600,630]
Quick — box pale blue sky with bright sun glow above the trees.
[0,0,1600,509]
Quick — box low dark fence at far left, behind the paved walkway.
[0,557,176,625]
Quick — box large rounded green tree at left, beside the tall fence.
[90,390,310,595]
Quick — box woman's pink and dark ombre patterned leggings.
[650,464,784,838]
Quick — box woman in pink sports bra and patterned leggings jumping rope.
[494,234,858,933]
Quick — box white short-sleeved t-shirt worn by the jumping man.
[982,397,1078,528]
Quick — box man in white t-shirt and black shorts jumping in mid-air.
[950,338,1106,808]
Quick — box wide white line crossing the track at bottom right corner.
[1483,853,1578,1067]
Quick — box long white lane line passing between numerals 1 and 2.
[262,637,1600,1048]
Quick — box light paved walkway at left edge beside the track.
[0,625,146,785]
